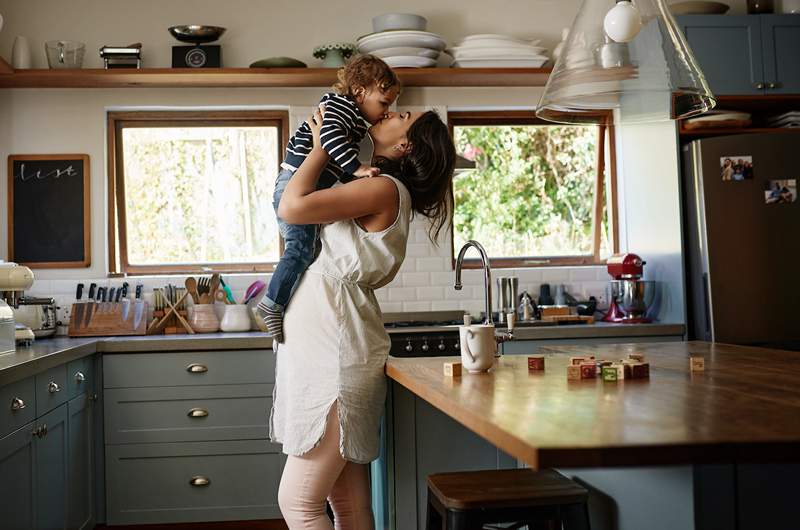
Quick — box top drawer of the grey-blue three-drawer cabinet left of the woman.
[103,350,275,388]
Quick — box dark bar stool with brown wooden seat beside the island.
[425,469,589,530]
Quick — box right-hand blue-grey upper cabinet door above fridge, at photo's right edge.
[759,15,800,94]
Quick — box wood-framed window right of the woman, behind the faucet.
[448,112,617,267]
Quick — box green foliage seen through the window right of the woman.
[453,125,609,257]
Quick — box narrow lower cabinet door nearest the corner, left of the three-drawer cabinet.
[67,393,94,530]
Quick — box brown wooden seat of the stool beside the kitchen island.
[428,469,588,510]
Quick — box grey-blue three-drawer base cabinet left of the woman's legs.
[103,350,285,525]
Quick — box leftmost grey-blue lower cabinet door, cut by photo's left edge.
[0,422,36,530]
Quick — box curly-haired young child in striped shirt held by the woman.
[258,55,400,342]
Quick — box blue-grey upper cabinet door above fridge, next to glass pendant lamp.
[677,15,764,95]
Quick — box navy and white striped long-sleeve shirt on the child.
[281,94,367,179]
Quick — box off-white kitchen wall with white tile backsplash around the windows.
[0,0,683,328]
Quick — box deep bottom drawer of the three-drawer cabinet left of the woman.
[106,440,285,525]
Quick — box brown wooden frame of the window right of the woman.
[447,110,619,269]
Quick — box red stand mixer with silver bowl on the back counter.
[603,253,656,324]
